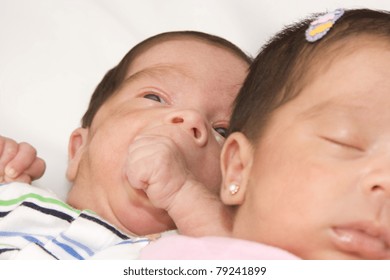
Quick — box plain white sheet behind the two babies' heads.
[0,0,390,198]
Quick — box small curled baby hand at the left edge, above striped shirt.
[0,136,46,184]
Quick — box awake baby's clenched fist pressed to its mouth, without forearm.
[126,136,190,211]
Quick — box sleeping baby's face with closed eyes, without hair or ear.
[230,40,390,259]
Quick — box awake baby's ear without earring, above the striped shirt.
[66,127,88,182]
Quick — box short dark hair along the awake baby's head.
[81,31,252,128]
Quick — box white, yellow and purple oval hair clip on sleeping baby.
[305,9,344,42]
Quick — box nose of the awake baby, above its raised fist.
[168,109,208,146]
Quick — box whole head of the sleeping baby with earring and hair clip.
[222,10,390,259]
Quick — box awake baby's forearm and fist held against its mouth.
[126,136,231,236]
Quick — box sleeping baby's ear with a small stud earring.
[221,132,253,205]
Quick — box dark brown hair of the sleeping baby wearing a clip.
[230,9,390,142]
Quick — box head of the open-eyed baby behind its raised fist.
[67,31,250,234]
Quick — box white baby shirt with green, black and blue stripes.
[0,182,150,260]
